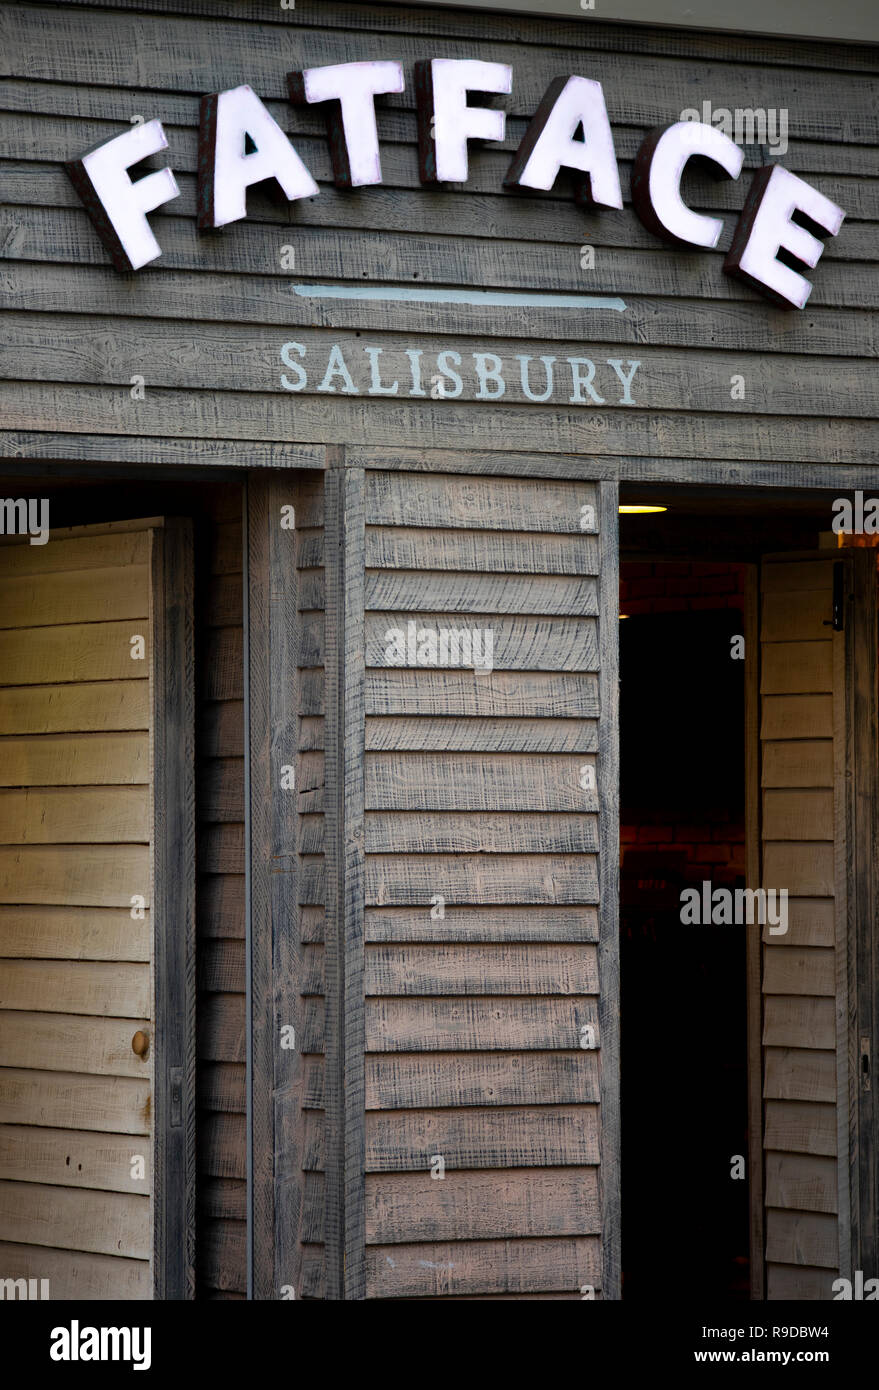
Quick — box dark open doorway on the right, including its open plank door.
[620,485,876,1300]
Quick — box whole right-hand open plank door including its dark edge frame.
[758,552,876,1298]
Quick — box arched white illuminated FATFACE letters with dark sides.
[67,58,846,309]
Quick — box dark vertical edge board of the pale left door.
[150,517,196,1300]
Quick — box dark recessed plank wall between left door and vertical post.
[196,487,248,1297]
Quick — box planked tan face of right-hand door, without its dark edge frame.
[758,559,848,1300]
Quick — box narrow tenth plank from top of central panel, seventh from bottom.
[364,904,598,945]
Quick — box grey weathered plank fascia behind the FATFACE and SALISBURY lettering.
[0,0,879,475]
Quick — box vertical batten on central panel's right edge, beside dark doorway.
[598,482,622,1300]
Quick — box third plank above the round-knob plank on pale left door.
[0,845,150,908]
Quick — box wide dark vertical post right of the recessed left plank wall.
[245,474,312,1300]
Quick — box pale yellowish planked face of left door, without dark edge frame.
[0,530,154,1298]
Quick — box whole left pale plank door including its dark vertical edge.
[0,523,193,1298]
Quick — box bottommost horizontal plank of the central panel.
[366,1236,601,1298]
